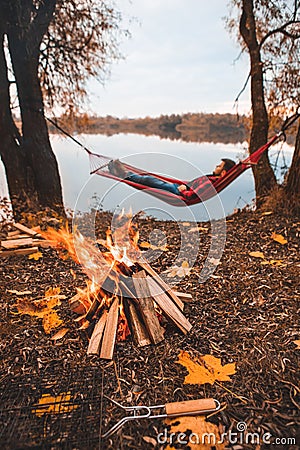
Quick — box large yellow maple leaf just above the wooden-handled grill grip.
[177,351,235,384]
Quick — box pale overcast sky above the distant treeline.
[88,0,250,118]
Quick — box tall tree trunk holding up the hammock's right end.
[240,0,276,207]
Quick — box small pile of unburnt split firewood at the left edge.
[0,223,50,257]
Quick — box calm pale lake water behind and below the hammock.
[0,134,292,221]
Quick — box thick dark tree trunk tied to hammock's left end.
[9,33,64,213]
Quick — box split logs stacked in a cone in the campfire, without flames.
[70,260,192,360]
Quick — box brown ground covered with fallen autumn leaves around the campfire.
[0,212,300,449]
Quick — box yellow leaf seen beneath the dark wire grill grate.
[32,392,78,417]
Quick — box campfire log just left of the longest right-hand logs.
[132,270,164,344]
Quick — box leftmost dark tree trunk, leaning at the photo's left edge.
[0,33,37,220]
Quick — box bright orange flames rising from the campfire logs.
[41,216,140,341]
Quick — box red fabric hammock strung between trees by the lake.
[89,132,282,206]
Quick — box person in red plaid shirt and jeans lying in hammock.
[108,158,235,199]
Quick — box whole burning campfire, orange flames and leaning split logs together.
[43,218,192,360]
